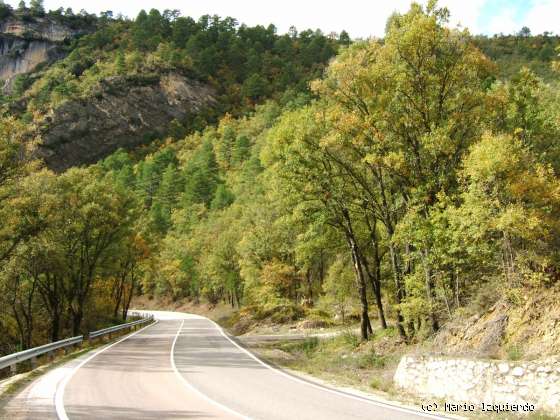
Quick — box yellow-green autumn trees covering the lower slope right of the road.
[121,0,559,352]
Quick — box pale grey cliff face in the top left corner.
[0,17,91,93]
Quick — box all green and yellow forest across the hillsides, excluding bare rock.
[0,2,560,360]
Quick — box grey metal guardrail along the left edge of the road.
[0,313,154,373]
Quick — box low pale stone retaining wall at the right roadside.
[394,356,560,413]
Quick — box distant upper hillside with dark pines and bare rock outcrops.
[0,4,347,170]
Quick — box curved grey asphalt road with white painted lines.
[4,312,444,420]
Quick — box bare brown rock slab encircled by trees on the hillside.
[38,73,215,171]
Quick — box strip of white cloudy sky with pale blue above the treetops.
[7,0,560,38]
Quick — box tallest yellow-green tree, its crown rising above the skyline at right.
[315,1,493,336]
